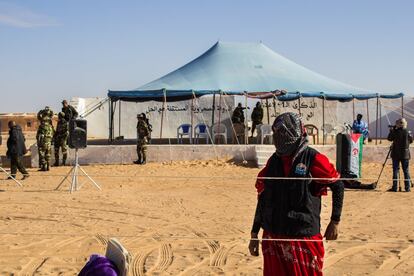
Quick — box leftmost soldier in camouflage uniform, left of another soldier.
[36,116,54,171]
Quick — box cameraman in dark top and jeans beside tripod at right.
[388,118,413,192]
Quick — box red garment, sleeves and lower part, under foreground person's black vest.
[255,153,340,276]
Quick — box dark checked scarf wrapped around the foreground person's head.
[272,112,307,156]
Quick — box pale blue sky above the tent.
[0,0,414,113]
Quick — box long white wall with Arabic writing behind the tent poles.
[71,95,414,143]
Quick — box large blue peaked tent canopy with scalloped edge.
[108,41,403,142]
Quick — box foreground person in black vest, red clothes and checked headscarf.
[249,112,344,276]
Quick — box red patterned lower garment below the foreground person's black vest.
[262,231,325,276]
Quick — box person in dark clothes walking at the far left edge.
[6,121,29,179]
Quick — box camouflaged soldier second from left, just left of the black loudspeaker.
[53,112,69,167]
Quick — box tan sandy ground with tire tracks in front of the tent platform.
[0,158,414,275]
